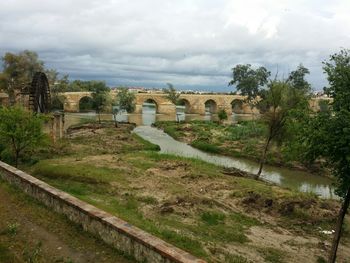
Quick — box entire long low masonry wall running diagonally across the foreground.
[0,161,205,263]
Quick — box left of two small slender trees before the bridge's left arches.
[91,81,110,123]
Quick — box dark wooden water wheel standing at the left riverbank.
[29,72,51,113]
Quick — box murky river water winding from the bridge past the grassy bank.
[65,105,336,198]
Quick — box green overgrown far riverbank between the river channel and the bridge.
[154,120,328,175]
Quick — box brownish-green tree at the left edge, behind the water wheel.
[0,50,44,105]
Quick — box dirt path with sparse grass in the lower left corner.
[0,181,131,263]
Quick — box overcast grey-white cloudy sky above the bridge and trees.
[0,0,350,91]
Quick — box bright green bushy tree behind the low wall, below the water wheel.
[0,106,44,167]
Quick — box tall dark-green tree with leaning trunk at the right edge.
[303,50,350,263]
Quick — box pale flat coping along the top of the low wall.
[0,161,205,263]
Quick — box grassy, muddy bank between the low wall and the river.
[19,123,348,262]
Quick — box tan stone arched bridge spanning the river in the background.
[64,91,251,114]
